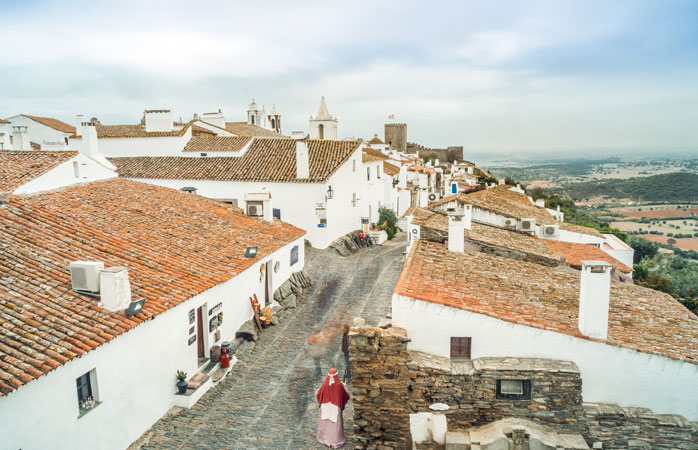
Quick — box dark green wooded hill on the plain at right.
[555,172,698,202]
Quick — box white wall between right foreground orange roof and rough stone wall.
[392,294,698,420]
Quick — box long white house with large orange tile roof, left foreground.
[0,168,305,450]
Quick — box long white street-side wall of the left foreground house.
[0,238,304,450]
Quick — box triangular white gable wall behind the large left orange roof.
[14,154,118,195]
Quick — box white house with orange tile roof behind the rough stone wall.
[392,239,698,421]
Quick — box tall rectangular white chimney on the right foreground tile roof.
[579,261,611,339]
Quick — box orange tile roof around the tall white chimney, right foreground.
[395,241,698,364]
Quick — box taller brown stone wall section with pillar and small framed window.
[350,327,582,449]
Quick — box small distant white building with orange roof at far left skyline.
[0,114,75,150]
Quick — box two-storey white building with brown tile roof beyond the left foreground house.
[109,136,370,248]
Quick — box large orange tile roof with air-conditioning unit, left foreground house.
[0,178,305,395]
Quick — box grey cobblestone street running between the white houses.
[134,234,405,450]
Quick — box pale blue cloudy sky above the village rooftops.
[0,0,698,156]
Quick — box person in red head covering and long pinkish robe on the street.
[315,368,349,448]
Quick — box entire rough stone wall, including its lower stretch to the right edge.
[349,325,698,450]
